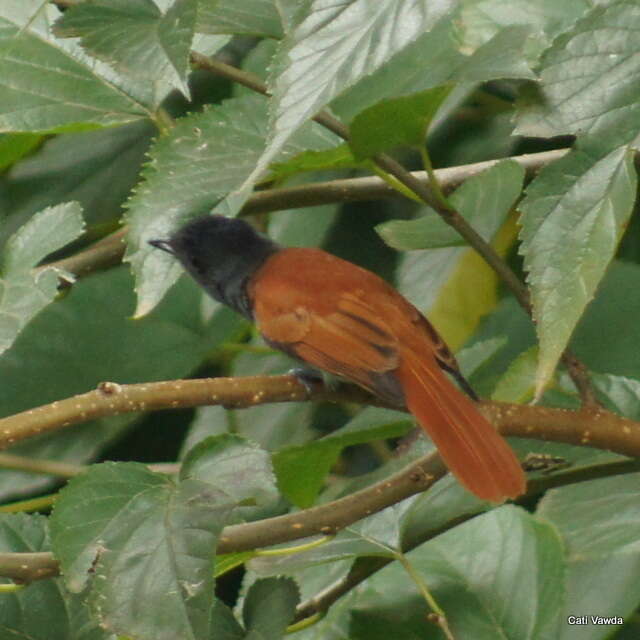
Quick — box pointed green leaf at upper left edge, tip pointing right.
[0,16,149,133]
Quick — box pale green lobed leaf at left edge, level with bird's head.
[0,202,84,354]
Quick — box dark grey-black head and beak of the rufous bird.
[149,215,279,319]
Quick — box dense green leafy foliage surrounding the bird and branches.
[0,0,640,640]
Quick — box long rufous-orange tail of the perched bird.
[396,350,526,502]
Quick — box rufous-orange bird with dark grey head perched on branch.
[149,214,526,503]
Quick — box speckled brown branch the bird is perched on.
[0,375,640,457]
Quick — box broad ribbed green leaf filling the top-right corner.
[516,0,640,149]
